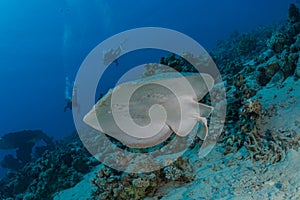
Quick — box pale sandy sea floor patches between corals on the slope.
[54,77,300,200]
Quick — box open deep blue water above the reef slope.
[0,0,294,178]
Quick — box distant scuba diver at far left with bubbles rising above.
[64,77,79,112]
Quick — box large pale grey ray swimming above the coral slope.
[83,72,214,148]
